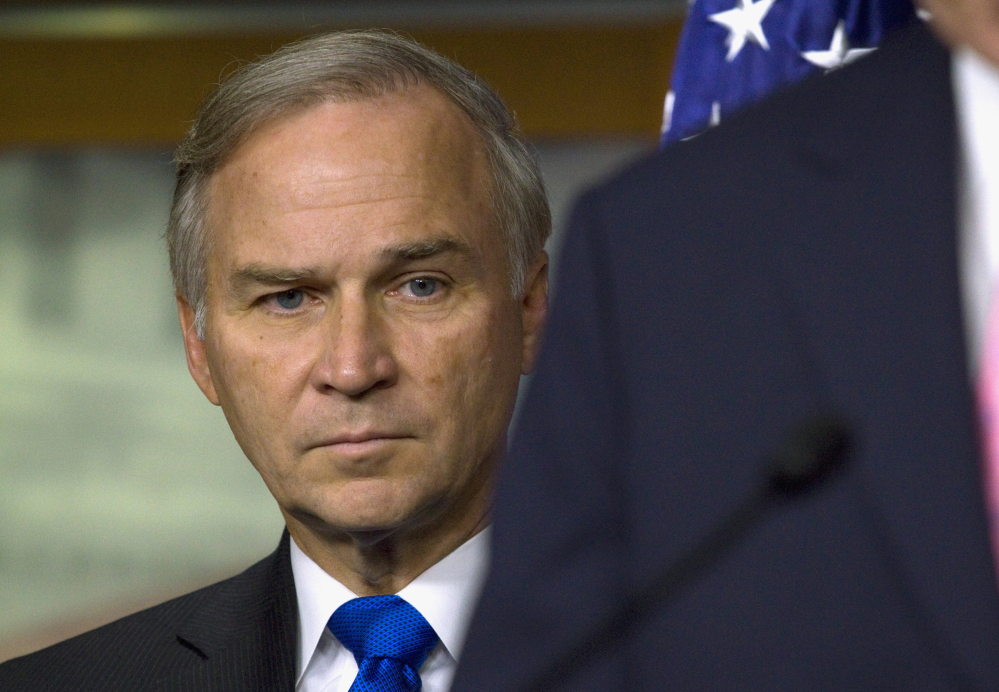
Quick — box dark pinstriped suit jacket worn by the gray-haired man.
[0,532,298,692]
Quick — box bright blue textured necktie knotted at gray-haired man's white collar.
[328,596,437,692]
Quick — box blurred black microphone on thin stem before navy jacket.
[523,411,851,692]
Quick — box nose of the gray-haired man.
[312,296,398,398]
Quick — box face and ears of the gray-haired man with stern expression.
[181,87,547,548]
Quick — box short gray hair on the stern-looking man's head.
[166,31,551,338]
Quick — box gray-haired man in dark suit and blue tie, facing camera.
[0,32,550,692]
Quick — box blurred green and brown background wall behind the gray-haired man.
[0,0,684,660]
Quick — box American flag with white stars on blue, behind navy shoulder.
[661,0,915,146]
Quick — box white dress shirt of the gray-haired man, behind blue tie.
[291,528,489,692]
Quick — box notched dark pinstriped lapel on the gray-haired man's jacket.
[162,531,298,692]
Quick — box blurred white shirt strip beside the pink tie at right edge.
[952,48,999,370]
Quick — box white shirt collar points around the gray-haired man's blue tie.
[291,528,490,675]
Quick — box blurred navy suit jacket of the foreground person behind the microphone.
[453,18,999,692]
